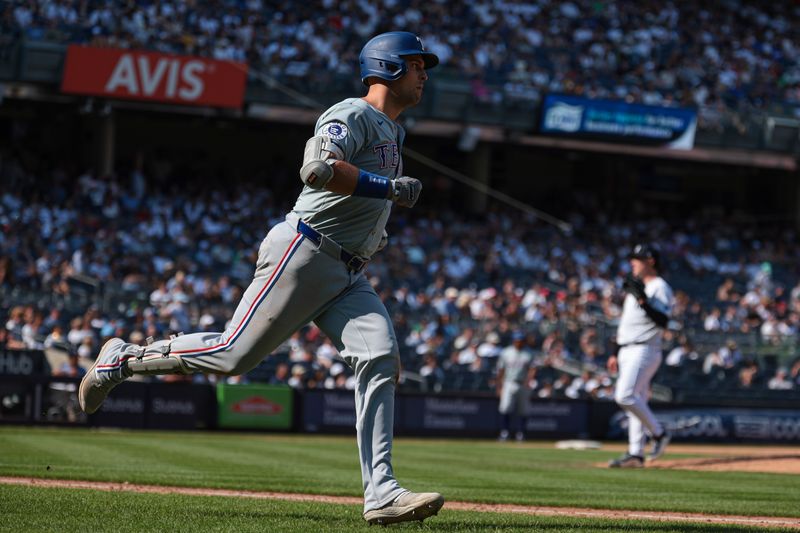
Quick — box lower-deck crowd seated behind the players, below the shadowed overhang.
[0,153,800,398]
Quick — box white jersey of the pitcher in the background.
[617,277,674,346]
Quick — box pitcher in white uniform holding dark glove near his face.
[608,244,673,468]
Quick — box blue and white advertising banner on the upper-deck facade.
[539,94,697,150]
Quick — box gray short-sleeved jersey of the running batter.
[294,98,405,258]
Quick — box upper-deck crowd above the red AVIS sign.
[0,0,800,115]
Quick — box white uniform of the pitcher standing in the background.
[614,277,673,457]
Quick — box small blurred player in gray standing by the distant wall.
[497,331,533,442]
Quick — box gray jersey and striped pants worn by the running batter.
[97,99,405,512]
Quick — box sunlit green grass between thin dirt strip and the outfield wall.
[0,426,800,516]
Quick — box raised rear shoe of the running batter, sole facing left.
[78,337,135,414]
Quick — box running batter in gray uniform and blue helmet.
[79,32,444,524]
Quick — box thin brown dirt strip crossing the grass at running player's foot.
[0,476,800,530]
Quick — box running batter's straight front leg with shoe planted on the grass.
[315,274,444,524]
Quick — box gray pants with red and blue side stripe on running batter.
[136,214,405,512]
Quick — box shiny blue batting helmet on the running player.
[358,31,439,85]
